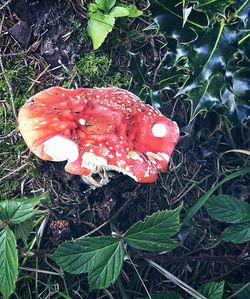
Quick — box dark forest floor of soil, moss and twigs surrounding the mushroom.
[0,0,250,298]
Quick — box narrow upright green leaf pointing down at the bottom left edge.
[0,228,18,298]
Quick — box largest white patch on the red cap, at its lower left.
[43,136,79,162]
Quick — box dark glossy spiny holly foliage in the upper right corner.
[151,0,250,126]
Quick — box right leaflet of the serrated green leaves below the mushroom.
[124,206,182,251]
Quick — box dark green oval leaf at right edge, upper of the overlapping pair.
[205,195,250,223]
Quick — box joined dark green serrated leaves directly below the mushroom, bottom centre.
[51,206,182,290]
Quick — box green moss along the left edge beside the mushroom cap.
[0,54,35,200]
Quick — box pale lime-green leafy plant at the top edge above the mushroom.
[87,0,142,50]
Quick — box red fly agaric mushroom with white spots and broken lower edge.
[18,87,179,186]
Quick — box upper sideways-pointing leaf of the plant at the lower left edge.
[0,193,47,224]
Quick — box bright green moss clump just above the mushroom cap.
[63,52,130,88]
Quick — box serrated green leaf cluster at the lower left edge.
[0,193,48,299]
